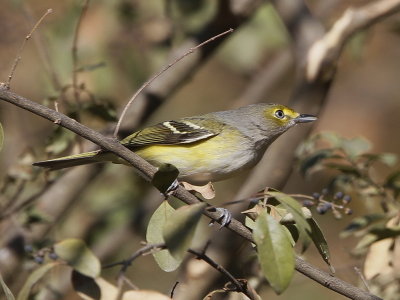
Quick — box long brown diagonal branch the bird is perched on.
[0,88,380,300]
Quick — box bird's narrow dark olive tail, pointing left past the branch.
[33,150,108,170]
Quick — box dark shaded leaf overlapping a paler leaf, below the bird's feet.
[163,203,206,260]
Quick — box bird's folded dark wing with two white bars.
[121,118,223,147]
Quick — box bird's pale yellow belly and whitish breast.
[135,136,259,185]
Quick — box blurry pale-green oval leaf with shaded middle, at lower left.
[54,239,101,278]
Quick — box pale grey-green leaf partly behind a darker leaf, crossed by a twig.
[146,201,181,272]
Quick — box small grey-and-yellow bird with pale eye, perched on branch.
[34,103,317,185]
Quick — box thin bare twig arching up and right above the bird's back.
[114,28,233,137]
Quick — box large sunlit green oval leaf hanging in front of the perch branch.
[253,212,295,294]
